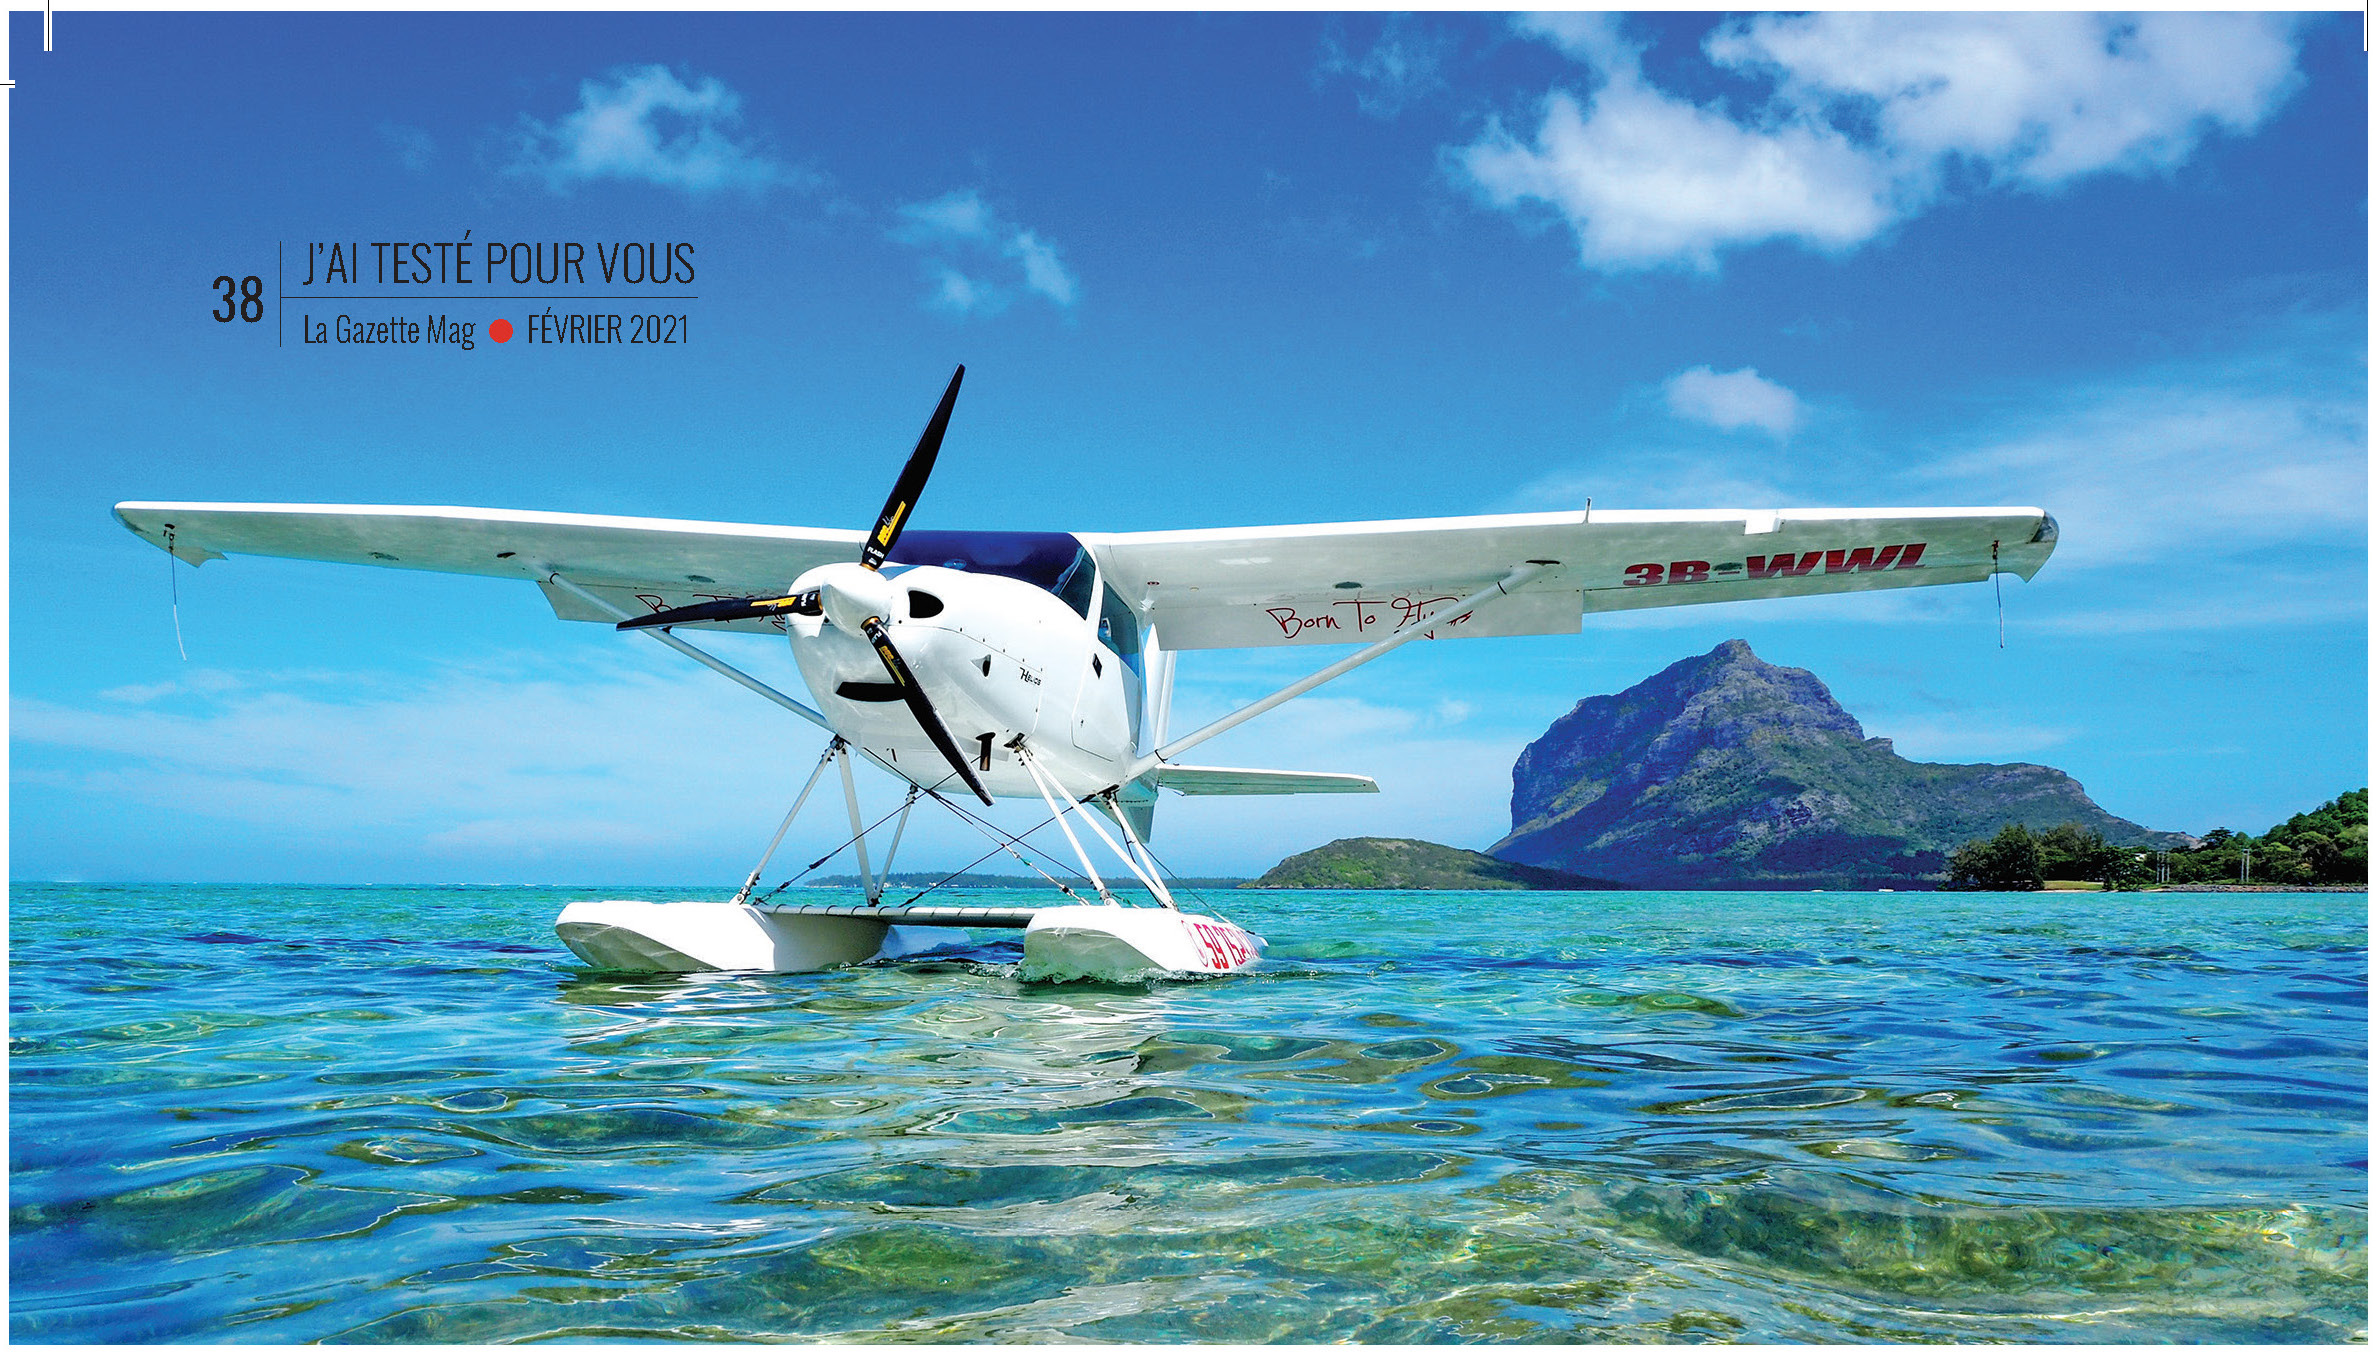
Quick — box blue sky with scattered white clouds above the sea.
[10,12,2367,886]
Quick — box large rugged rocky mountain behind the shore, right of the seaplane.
[1488,639,2189,888]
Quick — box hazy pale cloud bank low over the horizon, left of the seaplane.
[10,639,865,876]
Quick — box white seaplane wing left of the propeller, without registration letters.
[116,501,865,634]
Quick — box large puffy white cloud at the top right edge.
[1452,12,2299,271]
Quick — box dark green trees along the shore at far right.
[1947,789,2370,891]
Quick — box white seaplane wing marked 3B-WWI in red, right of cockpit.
[1079,506,2056,651]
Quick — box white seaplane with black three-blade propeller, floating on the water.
[116,366,2056,981]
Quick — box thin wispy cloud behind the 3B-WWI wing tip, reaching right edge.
[1493,309,2370,634]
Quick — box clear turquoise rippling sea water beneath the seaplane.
[10,886,2367,1342]
